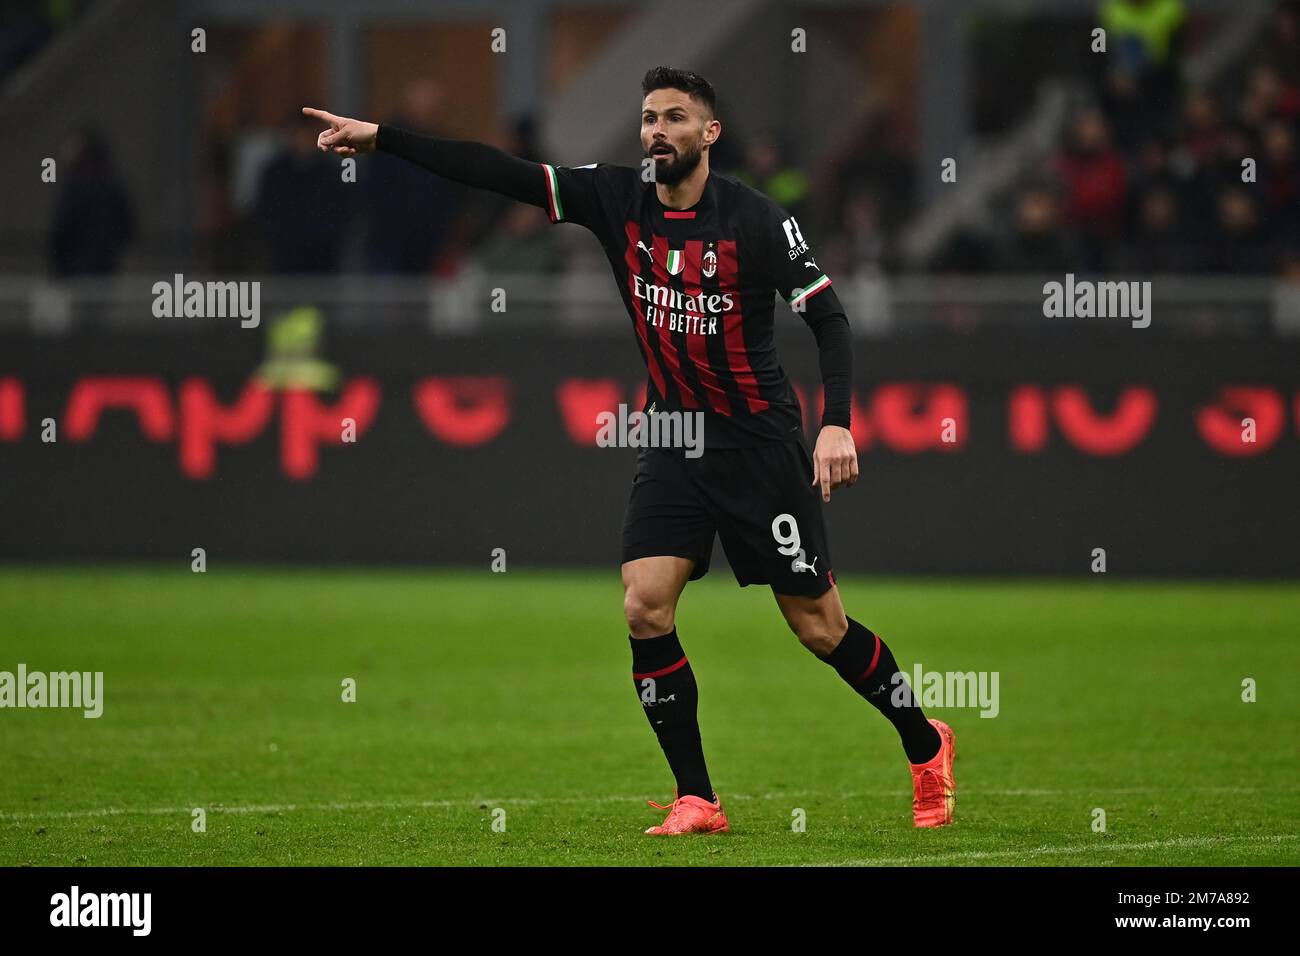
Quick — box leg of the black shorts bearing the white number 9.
[701,441,835,597]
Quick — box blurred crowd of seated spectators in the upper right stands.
[933,0,1300,277]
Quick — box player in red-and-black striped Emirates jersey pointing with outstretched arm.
[303,66,956,834]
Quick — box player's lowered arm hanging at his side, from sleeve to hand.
[768,203,858,501]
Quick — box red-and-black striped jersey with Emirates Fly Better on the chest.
[542,164,842,447]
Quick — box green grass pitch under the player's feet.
[0,566,1300,866]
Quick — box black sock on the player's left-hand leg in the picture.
[628,628,714,803]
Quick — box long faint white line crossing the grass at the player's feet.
[0,784,1258,821]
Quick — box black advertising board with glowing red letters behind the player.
[0,324,1300,576]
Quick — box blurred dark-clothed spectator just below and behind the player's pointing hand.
[255,111,350,274]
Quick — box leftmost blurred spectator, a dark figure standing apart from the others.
[51,130,135,276]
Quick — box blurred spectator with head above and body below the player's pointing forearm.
[361,79,462,274]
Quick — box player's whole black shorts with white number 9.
[623,440,835,597]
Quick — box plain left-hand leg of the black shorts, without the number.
[623,449,714,580]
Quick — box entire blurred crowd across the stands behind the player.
[40,0,1300,277]
